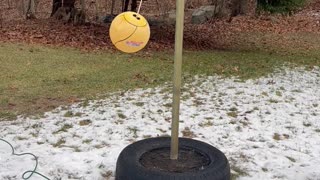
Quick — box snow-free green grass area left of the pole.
[0,44,171,119]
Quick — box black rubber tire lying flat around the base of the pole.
[116,137,230,180]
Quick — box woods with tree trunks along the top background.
[0,0,305,24]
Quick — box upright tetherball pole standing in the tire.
[170,0,184,160]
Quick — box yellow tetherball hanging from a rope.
[110,12,150,53]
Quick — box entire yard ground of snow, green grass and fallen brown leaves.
[0,2,320,180]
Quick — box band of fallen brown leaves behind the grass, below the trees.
[0,2,320,52]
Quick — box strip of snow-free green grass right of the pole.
[184,51,320,79]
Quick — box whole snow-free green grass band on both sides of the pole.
[0,43,320,120]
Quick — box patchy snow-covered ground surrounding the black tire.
[0,67,320,180]
